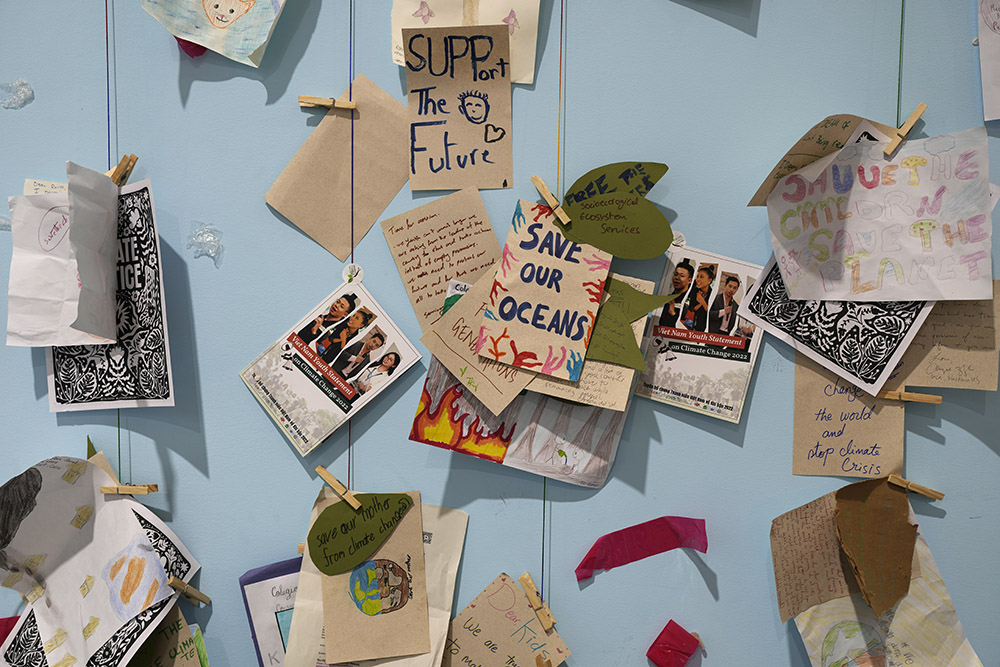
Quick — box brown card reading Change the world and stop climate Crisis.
[792,354,904,477]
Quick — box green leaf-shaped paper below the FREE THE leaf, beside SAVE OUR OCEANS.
[586,278,677,371]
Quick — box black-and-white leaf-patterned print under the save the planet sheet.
[740,256,934,394]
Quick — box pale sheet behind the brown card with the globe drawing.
[284,487,469,667]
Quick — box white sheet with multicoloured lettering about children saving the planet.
[767,127,996,301]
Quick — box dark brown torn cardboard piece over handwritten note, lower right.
[834,478,917,616]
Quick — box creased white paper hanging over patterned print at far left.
[7,162,118,347]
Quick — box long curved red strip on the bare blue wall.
[576,516,708,581]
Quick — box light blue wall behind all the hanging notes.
[0,0,1000,667]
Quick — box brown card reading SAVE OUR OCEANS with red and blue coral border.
[476,200,611,382]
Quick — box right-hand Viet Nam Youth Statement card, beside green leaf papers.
[635,246,761,423]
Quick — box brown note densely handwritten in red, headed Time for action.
[382,188,500,332]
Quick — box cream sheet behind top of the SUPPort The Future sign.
[392,0,539,84]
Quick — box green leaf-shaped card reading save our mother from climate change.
[308,493,413,575]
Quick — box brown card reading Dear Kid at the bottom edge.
[441,573,570,667]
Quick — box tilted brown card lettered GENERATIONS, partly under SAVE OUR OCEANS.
[420,269,536,415]
